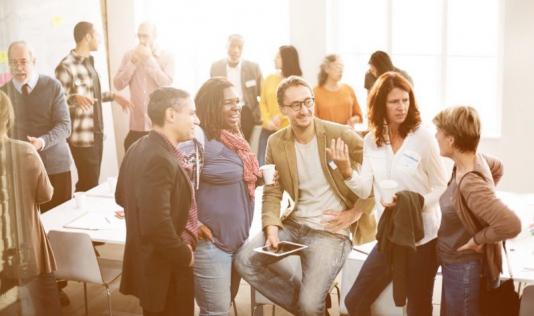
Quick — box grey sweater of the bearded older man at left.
[0,75,71,175]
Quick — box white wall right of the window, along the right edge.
[480,0,534,192]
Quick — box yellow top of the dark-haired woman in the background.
[260,74,289,129]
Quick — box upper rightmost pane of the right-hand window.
[447,0,499,56]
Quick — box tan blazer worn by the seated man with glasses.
[262,118,376,244]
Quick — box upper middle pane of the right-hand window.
[392,0,443,54]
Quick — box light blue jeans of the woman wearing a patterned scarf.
[194,240,240,316]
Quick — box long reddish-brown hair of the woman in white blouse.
[367,71,421,147]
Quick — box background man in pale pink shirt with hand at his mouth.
[113,22,174,151]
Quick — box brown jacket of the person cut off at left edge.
[0,139,56,276]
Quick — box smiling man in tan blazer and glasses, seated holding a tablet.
[234,76,376,316]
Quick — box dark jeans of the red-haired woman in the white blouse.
[345,239,438,316]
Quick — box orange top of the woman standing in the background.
[313,84,362,125]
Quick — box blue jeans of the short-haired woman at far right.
[440,260,481,316]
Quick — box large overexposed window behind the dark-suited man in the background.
[136,0,289,93]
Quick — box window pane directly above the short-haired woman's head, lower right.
[446,57,501,136]
